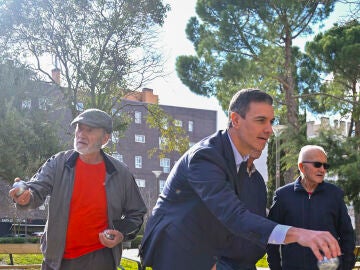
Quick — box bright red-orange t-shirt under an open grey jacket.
[64,158,108,259]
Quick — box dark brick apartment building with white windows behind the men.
[112,88,217,210]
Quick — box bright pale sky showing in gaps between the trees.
[144,0,347,181]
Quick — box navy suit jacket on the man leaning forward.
[140,131,276,269]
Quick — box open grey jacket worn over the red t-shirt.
[17,150,147,270]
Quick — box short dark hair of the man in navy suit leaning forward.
[228,88,273,127]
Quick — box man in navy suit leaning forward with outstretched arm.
[140,89,340,270]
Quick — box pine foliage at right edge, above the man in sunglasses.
[302,21,360,118]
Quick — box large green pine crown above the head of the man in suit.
[176,0,335,116]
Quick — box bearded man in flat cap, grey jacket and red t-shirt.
[9,109,146,270]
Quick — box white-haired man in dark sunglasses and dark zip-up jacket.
[267,145,355,270]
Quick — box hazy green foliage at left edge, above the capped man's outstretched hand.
[0,103,59,181]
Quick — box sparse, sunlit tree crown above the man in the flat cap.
[0,0,169,116]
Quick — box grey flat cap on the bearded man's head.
[71,109,113,134]
